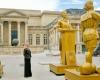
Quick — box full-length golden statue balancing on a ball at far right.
[80,0,100,74]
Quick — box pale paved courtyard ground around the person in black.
[0,53,100,80]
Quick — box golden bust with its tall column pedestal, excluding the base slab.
[57,11,76,66]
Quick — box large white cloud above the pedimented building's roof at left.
[0,0,60,10]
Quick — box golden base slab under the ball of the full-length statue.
[65,69,100,80]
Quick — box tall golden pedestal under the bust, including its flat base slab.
[49,29,78,75]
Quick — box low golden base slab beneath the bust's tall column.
[49,64,78,75]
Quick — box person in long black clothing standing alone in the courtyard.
[23,45,32,77]
